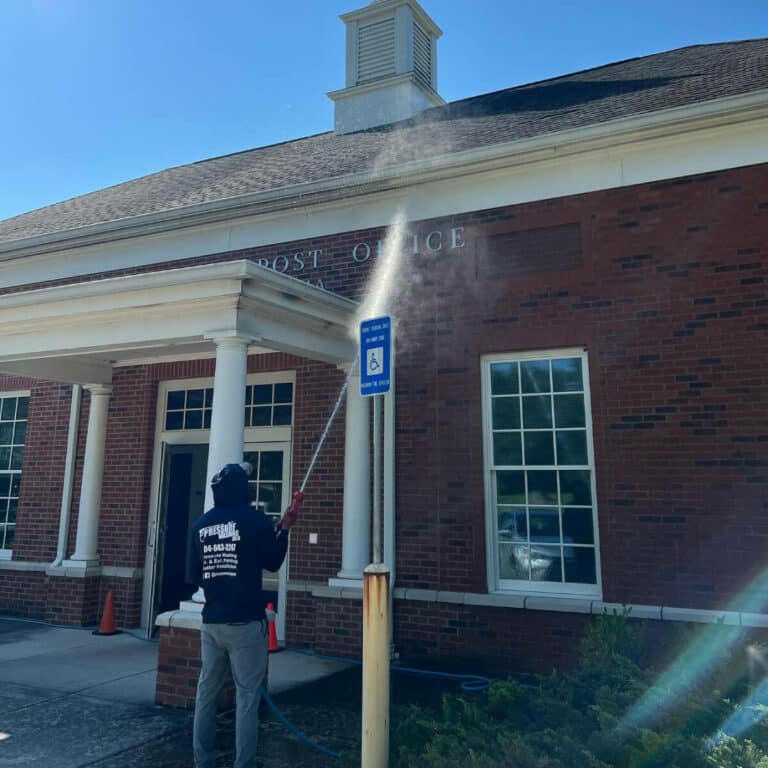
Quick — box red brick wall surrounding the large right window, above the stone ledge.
[390,166,768,608]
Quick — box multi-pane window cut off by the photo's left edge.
[0,393,29,551]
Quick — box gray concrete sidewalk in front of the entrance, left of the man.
[0,617,347,768]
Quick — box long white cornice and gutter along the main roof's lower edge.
[0,89,768,260]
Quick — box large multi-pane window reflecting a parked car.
[483,352,598,593]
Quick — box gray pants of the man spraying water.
[192,621,267,768]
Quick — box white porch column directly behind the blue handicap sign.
[329,367,371,586]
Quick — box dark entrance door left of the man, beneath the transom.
[154,444,208,616]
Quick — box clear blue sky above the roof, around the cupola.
[0,0,768,219]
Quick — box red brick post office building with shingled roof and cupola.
[0,0,768,705]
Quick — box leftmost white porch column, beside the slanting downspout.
[65,384,112,567]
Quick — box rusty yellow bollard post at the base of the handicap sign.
[360,563,390,768]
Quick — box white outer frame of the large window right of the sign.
[480,347,602,599]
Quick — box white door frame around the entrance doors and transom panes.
[141,370,296,641]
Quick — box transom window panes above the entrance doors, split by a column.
[165,382,293,431]
